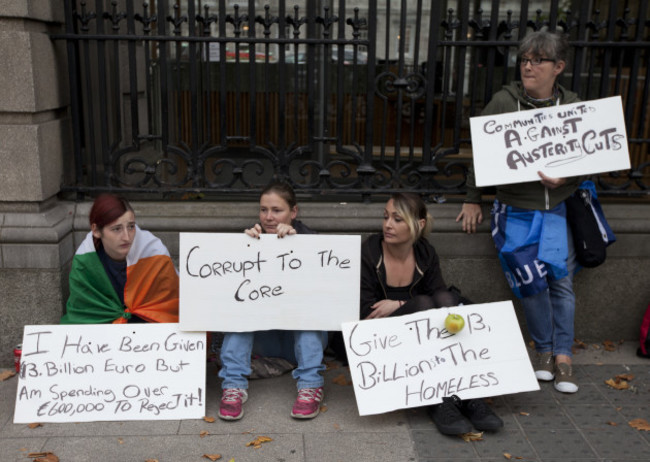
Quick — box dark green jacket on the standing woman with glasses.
[465,82,587,210]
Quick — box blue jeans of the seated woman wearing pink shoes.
[219,330,327,390]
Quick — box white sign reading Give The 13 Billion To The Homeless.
[343,301,539,415]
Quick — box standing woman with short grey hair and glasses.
[456,31,586,393]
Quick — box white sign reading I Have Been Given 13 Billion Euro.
[14,324,206,423]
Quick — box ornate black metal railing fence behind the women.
[52,0,650,199]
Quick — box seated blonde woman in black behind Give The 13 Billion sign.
[360,193,503,435]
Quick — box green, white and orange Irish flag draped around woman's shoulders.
[61,227,178,324]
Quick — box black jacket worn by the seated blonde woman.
[360,234,447,319]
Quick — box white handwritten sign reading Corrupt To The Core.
[179,233,361,332]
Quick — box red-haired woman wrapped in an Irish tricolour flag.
[61,194,178,324]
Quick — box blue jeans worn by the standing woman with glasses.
[521,226,577,356]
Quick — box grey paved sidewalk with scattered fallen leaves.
[0,342,650,462]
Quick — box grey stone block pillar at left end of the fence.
[0,0,74,365]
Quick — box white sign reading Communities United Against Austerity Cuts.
[470,96,630,187]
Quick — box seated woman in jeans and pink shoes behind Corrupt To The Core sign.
[219,182,327,420]
